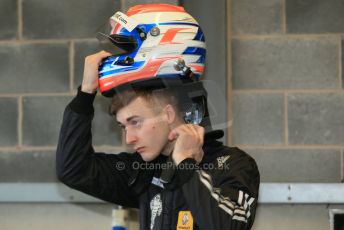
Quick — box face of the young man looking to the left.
[116,97,170,161]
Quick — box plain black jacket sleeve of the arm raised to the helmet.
[56,89,138,208]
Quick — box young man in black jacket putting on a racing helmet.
[57,4,259,230]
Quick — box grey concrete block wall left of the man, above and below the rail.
[0,0,178,230]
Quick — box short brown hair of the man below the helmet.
[109,89,180,115]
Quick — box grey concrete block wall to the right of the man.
[230,0,344,230]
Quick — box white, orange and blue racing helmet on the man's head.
[97,4,206,96]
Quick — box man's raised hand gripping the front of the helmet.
[81,51,111,93]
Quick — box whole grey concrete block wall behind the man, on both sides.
[0,0,344,230]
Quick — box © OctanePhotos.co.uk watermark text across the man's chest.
[115,161,229,171]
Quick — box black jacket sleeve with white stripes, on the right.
[177,148,260,230]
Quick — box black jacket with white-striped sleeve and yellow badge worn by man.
[56,90,259,230]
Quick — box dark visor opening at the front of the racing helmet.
[97,32,137,56]
